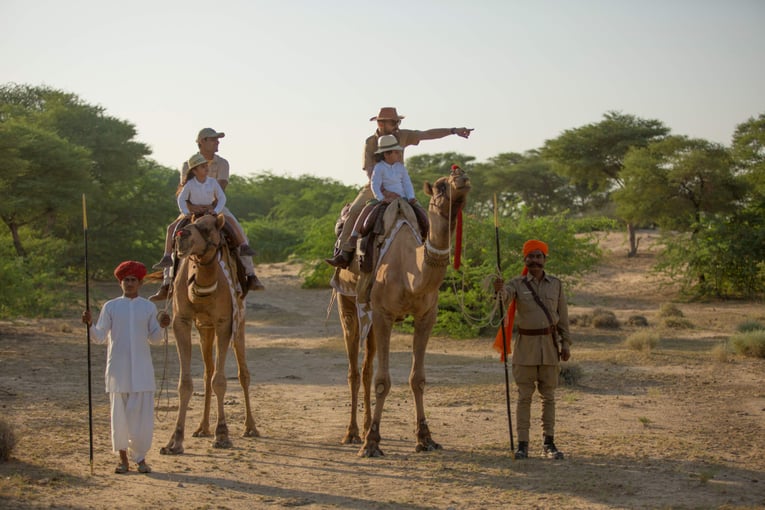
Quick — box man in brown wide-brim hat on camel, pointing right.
[326,106,473,268]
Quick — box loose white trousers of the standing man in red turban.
[109,391,154,463]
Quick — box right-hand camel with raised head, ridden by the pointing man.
[336,169,470,457]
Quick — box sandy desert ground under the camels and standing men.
[0,233,765,509]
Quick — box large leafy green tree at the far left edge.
[0,84,177,269]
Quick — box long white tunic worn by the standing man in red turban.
[90,296,164,393]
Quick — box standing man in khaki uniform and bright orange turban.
[494,239,571,459]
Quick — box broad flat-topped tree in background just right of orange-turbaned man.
[541,112,669,257]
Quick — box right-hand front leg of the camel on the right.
[409,307,441,452]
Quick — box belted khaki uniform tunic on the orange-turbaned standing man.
[503,273,571,365]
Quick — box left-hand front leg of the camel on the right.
[359,312,393,457]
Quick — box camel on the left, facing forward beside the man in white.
[160,214,259,454]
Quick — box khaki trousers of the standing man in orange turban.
[513,365,560,442]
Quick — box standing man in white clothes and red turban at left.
[83,261,170,473]
